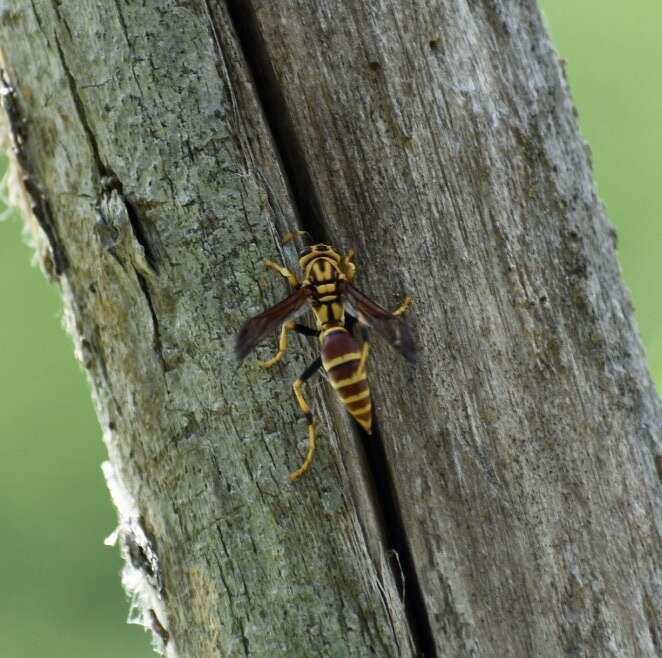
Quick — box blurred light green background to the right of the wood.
[540,0,662,390]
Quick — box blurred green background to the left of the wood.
[0,184,154,658]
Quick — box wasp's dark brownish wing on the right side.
[340,281,416,363]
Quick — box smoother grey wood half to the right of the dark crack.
[246,0,662,656]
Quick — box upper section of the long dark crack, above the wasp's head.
[226,0,328,242]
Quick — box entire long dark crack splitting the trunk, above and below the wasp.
[226,0,437,658]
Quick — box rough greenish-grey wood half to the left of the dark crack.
[0,1,410,658]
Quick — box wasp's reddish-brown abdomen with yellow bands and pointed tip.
[322,328,372,434]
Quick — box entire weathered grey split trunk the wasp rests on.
[0,0,662,656]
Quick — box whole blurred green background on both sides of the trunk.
[0,0,662,658]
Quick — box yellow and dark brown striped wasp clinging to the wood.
[235,236,416,480]
